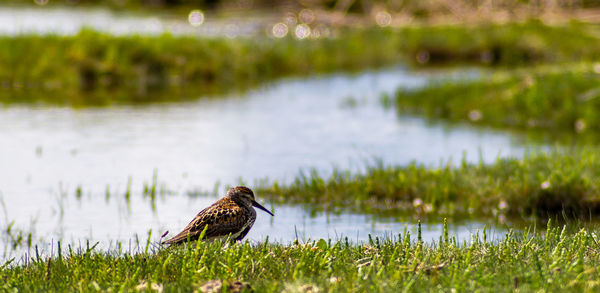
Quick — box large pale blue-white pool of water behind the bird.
[0,68,526,258]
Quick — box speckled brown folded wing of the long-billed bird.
[163,199,249,244]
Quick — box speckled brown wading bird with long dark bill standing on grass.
[163,186,274,244]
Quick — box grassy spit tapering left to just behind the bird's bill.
[257,149,600,220]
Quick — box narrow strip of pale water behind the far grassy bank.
[0,6,275,38]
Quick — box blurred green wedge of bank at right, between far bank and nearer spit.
[396,64,600,133]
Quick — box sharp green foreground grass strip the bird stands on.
[0,226,600,292]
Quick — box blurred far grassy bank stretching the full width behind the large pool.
[0,22,600,105]
